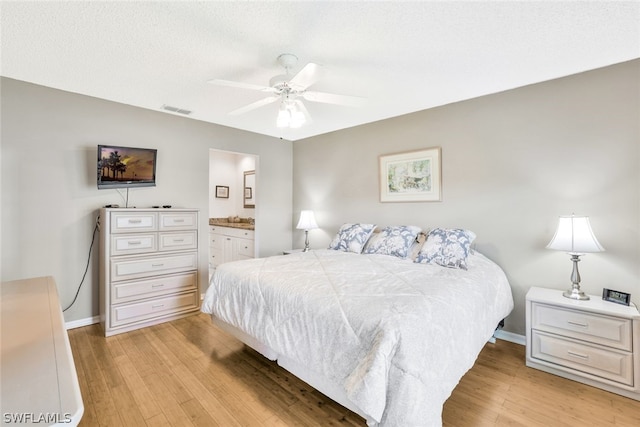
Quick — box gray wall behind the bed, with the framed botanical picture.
[293,60,640,334]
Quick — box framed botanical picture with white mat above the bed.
[379,147,442,202]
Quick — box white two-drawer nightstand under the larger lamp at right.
[526,288,640,400]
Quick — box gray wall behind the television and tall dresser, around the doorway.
[0,78,293,321]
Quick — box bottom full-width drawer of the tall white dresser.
[110,290,198,328]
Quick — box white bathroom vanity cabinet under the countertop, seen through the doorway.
[209,225,255,268]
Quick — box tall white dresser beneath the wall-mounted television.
[100,209,199,336]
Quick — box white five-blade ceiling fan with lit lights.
[209,53,365,128]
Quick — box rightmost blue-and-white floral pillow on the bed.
[415,228,476,270]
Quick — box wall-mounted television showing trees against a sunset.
[98,145,158,189]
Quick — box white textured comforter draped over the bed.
[202,250,513,427]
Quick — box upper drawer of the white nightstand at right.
[531,303,632,351]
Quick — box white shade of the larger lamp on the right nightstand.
[547,215,604,254]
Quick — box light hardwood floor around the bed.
[69,314,640,427]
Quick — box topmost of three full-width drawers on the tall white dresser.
[111,252,198,281]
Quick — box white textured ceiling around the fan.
[0,1,640,140]
